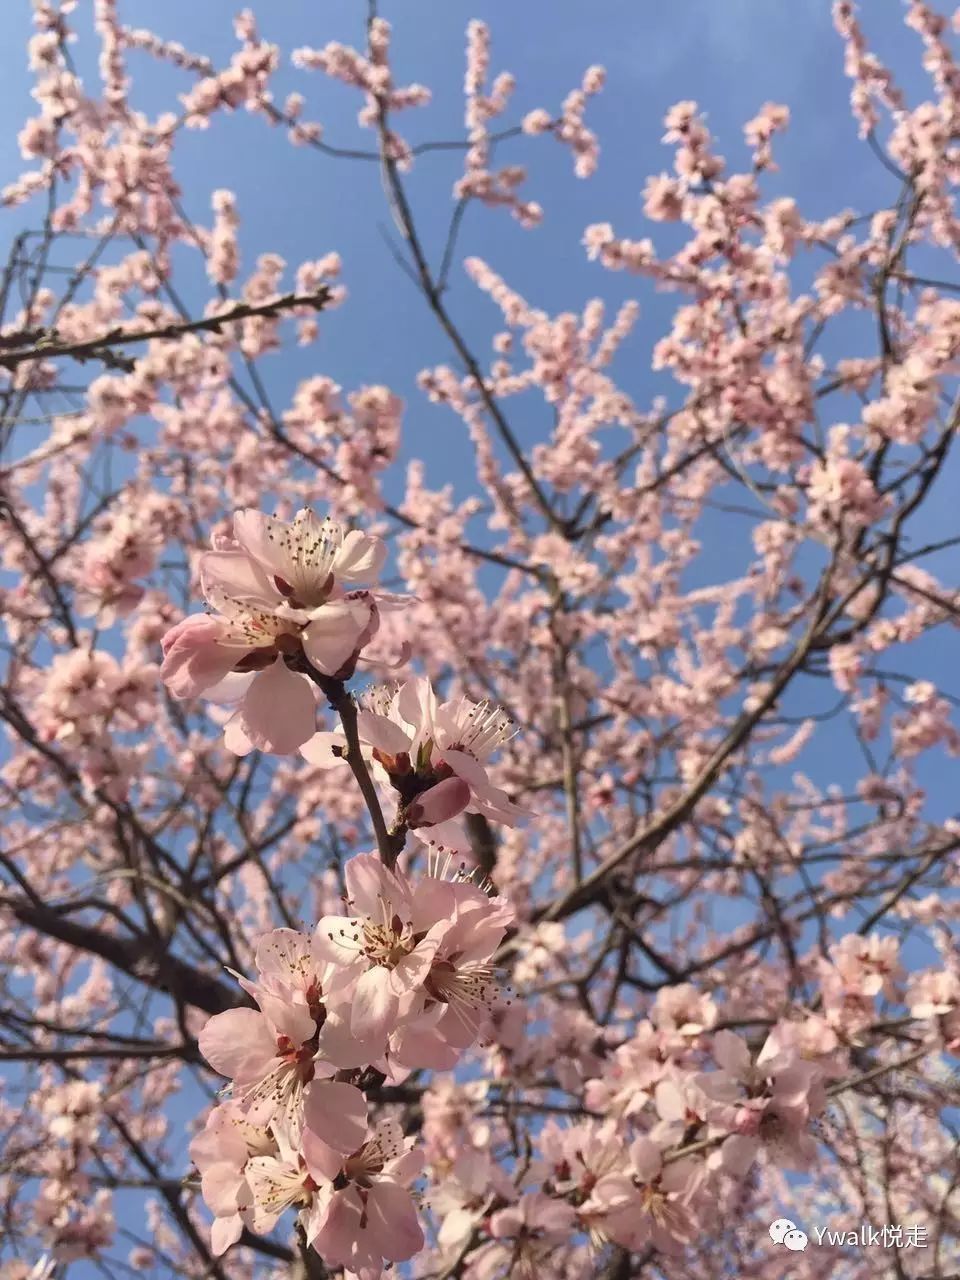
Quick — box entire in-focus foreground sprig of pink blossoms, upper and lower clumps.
[160,508,535,1280]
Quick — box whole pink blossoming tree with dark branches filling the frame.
[0,0,960,1280]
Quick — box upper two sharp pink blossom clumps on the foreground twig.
[160,508,535,852]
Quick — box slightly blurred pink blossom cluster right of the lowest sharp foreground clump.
[414,1008,838,1280]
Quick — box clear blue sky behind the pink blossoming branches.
[0,0,955,1274]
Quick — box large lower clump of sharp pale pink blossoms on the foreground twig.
[191,854,512,1280]
